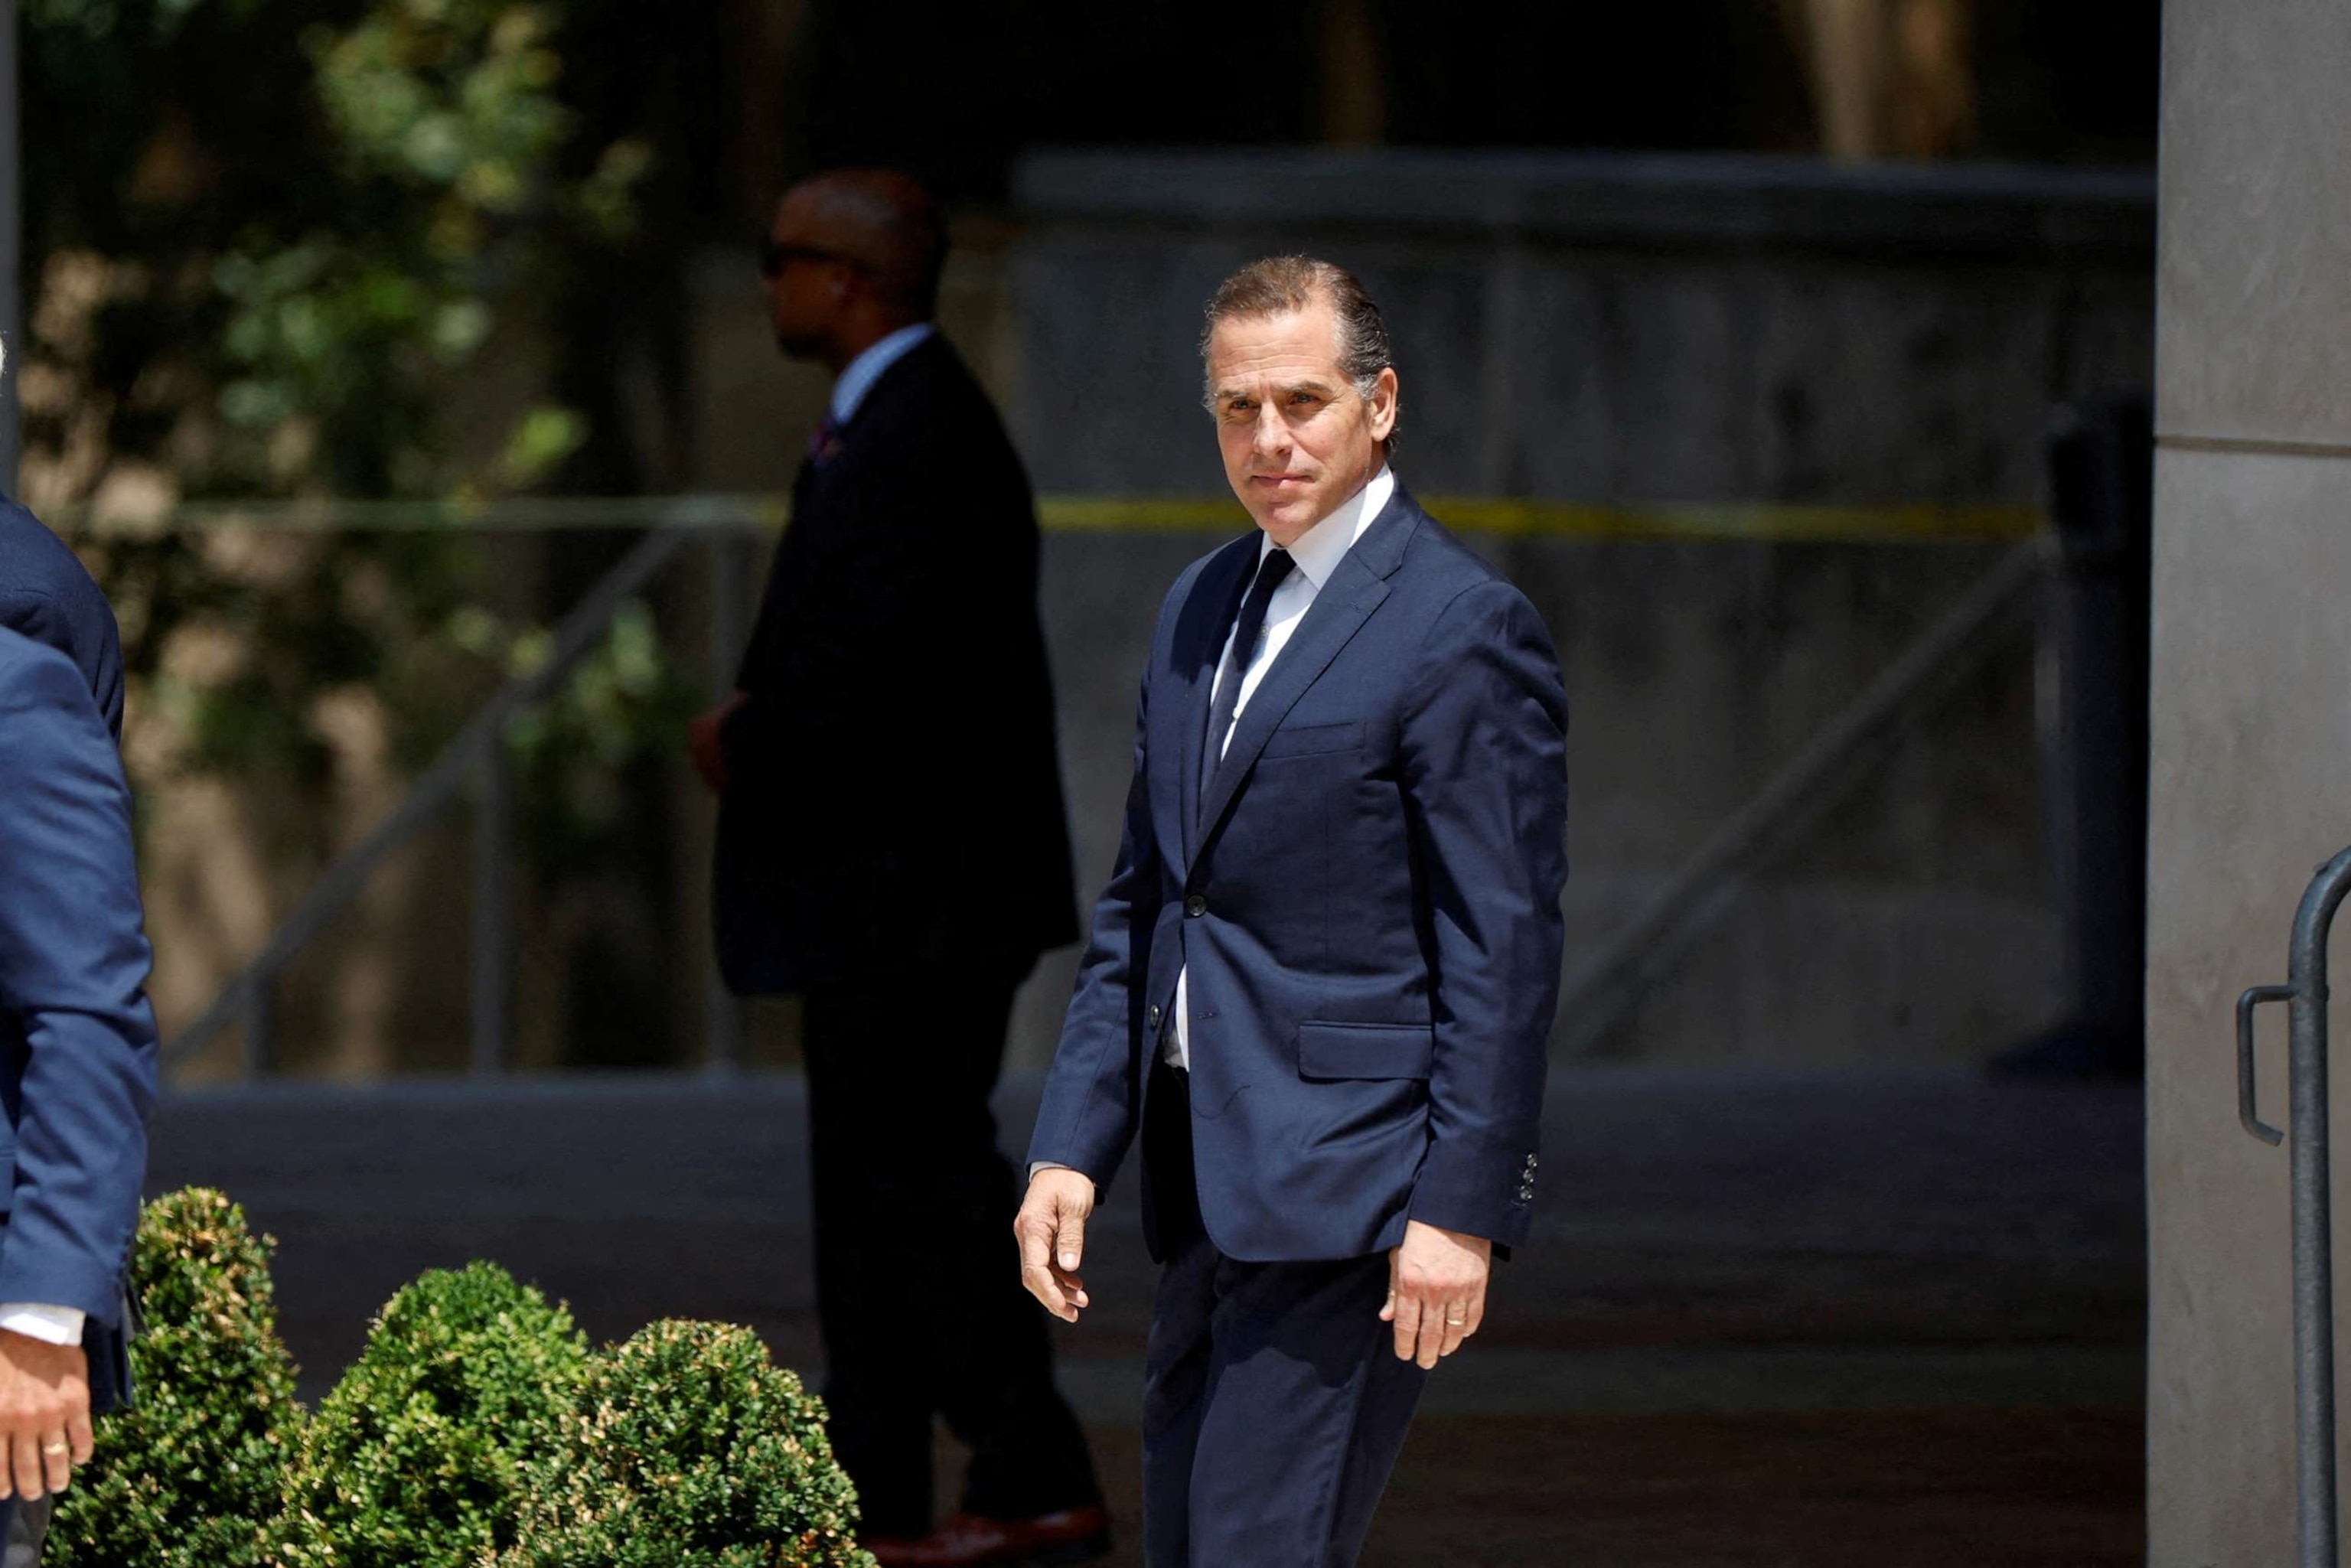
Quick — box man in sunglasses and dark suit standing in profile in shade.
[691,171,1107,1568]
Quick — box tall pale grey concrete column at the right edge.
[2147,0,2351,1568]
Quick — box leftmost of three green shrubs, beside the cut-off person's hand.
[44,1187,301,1568]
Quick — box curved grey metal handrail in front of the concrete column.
[2235,849,2351,1568]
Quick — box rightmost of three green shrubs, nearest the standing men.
[496,1321,872,1568]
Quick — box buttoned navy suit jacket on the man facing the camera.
[1030,487,1568,1263]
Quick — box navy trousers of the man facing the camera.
[1143,1065,1427,1568]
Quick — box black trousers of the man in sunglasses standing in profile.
[802,971,1101,1537]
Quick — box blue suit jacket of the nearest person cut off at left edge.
[0,630,155,1408]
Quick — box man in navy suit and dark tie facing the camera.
[1013,256,1568,1568]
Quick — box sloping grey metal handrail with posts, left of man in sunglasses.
[162,496,771,1074]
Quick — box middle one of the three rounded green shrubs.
[270,1263,588,1568]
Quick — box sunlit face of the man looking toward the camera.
[1208,298,1397,548]
